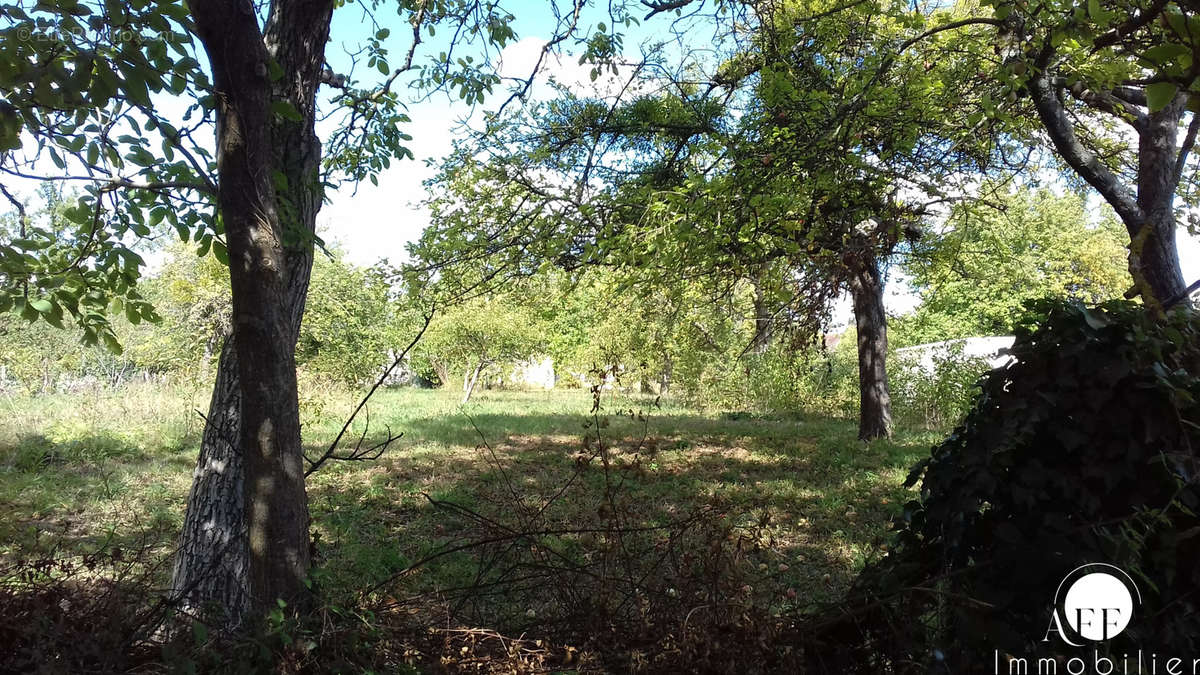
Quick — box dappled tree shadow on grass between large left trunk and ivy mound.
[310,401,928,612]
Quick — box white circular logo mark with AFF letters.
[1055,562,1141,644]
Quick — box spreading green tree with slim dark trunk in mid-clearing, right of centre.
[415,2,1012,438]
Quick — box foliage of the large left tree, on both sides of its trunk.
[0,0,600,357]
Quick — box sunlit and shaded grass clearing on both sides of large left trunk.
[0,384,935,624]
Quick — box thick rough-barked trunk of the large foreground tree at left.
[172,1,332,629]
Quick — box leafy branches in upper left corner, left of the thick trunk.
[0,0,212,343]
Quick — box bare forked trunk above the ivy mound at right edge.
[1028,66,1195,304]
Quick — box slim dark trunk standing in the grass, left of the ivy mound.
[850,252,892,441]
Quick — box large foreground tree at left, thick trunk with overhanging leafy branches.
[0,0,614,628]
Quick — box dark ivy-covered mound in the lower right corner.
[856,301,1200,673]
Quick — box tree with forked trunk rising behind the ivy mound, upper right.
[983,0,1200,305]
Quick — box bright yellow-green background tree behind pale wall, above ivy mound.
[900,189,1128,344]
